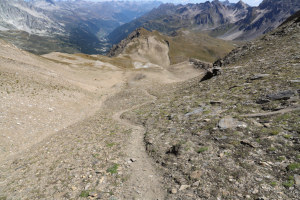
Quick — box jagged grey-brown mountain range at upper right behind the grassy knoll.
[108,0,300,43]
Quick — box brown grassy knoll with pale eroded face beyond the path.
[108,28,234,66]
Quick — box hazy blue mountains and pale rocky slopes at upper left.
[0,0,161,54]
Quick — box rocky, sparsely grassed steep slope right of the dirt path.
[123,8,300,199]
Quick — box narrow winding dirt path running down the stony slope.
[113,90,164,200]
